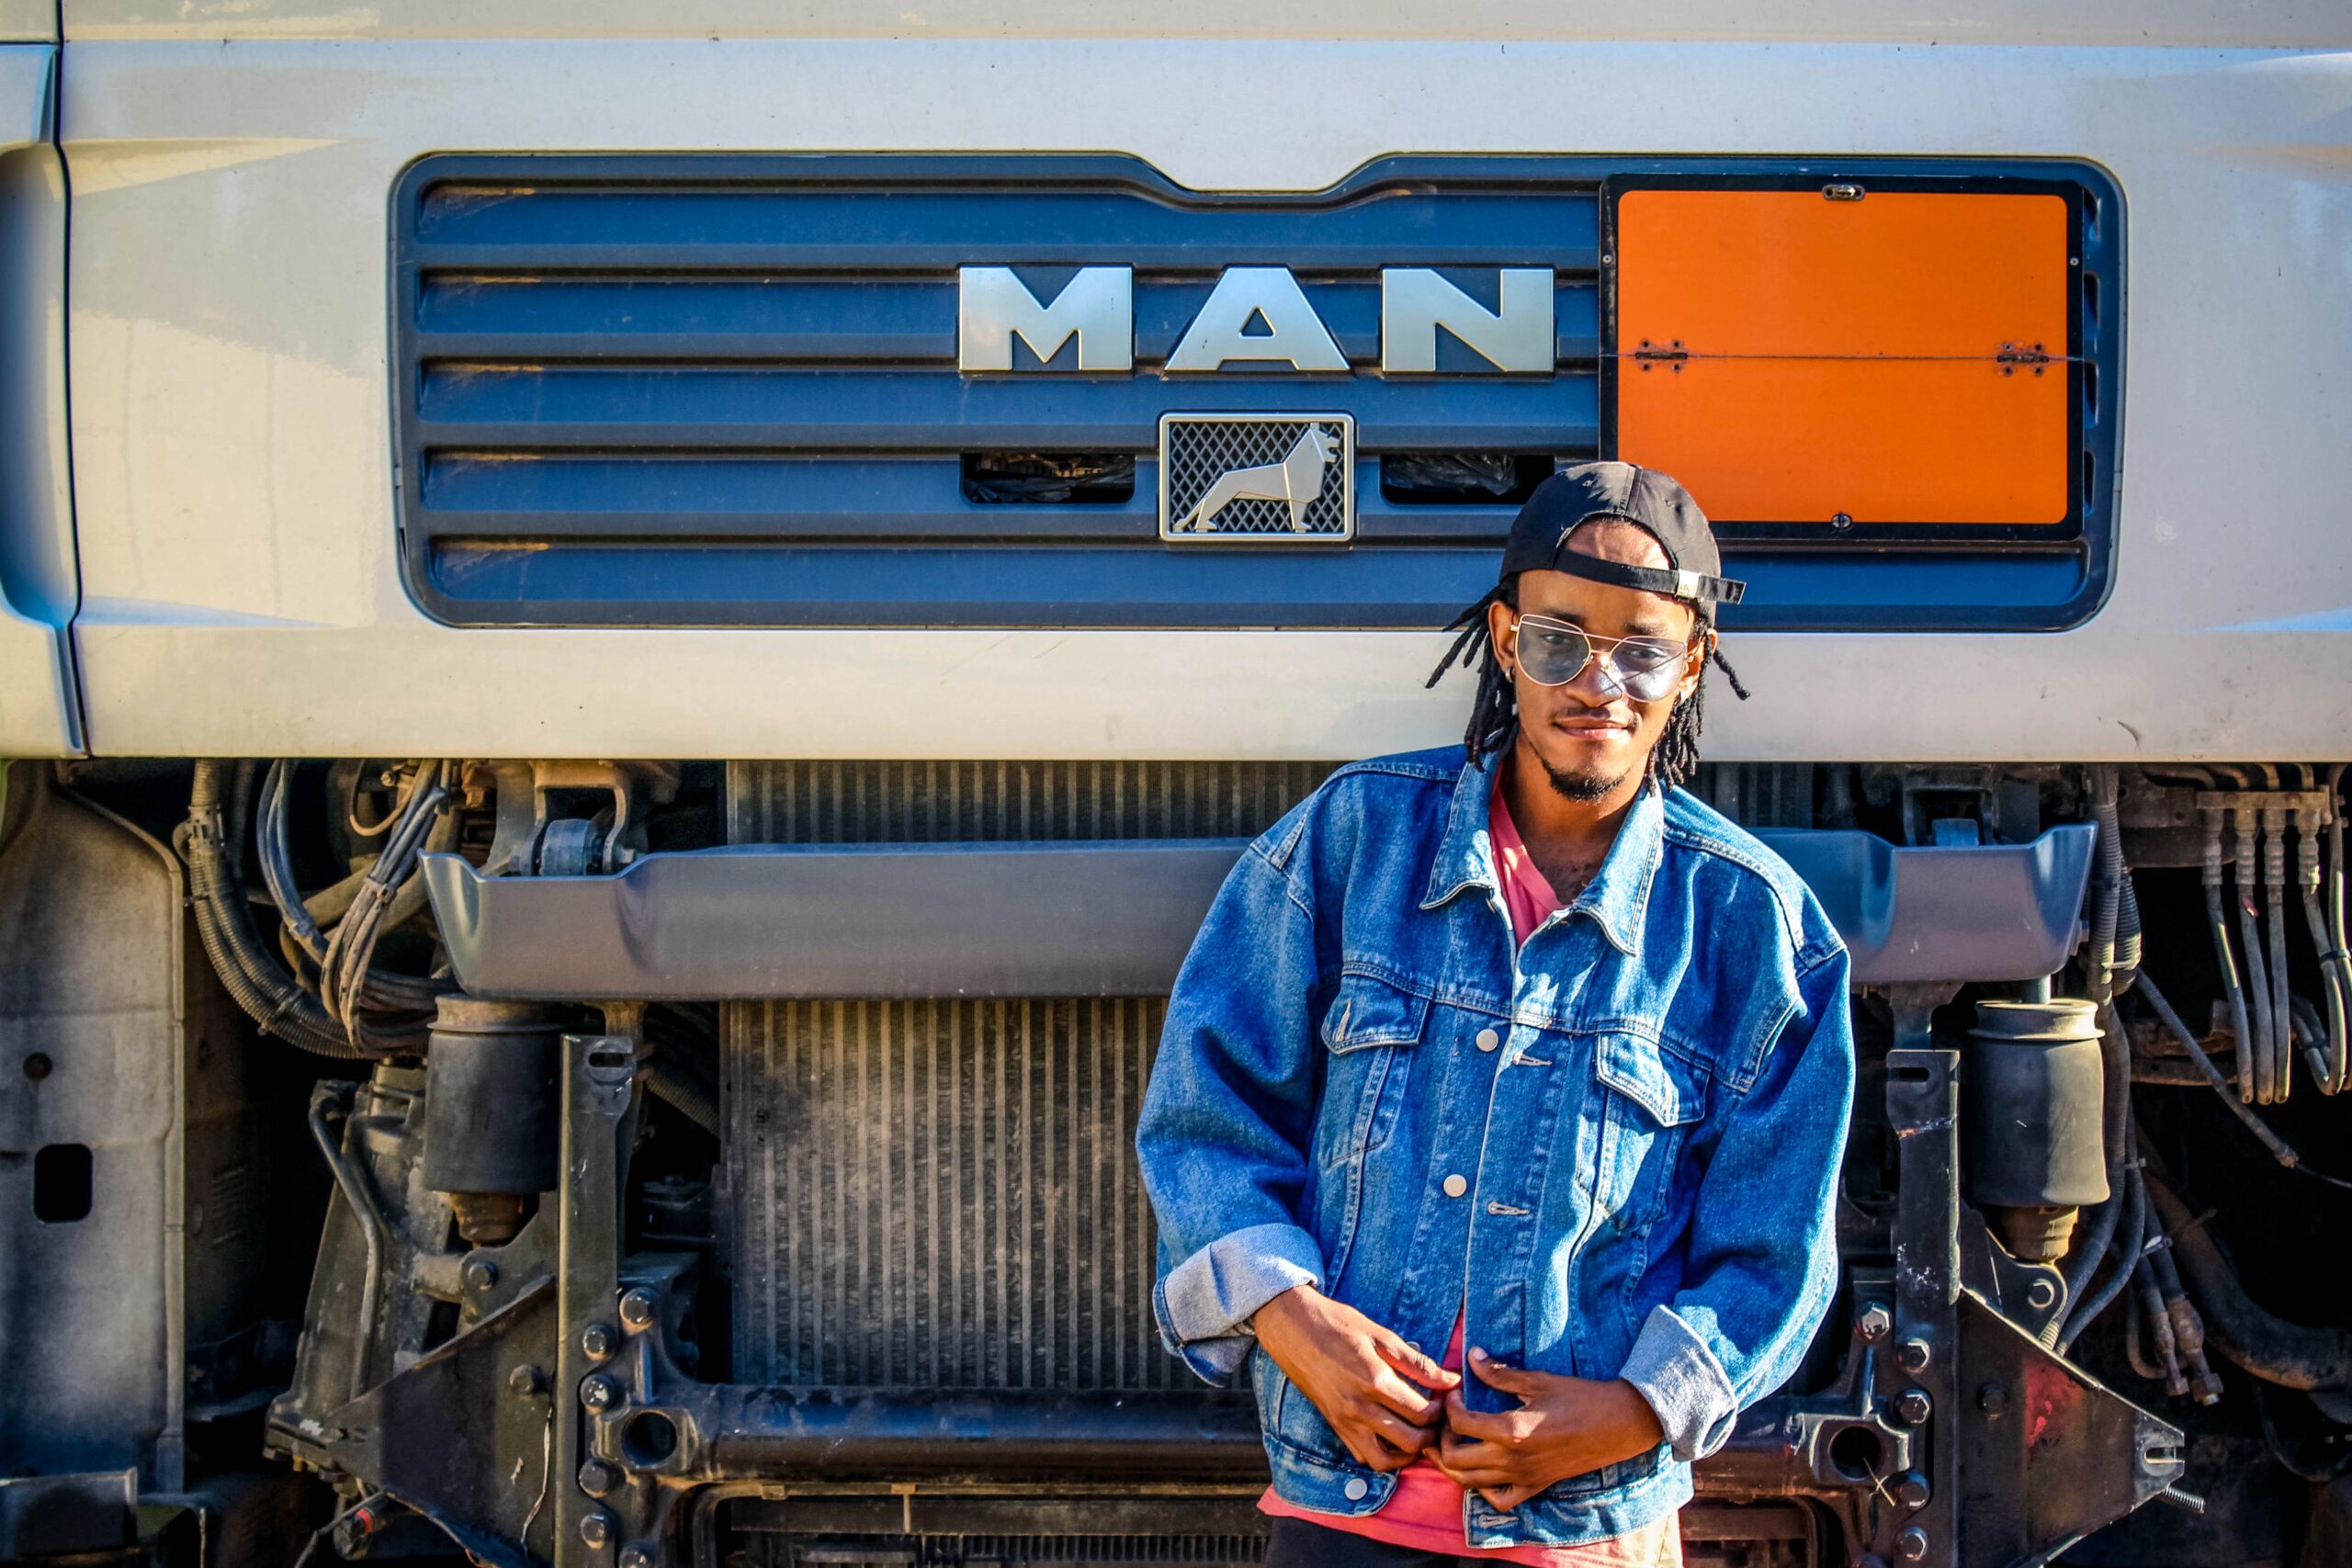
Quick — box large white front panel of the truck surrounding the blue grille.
[41,0,2352,760]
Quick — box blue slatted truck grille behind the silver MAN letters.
[393,155,2105,627]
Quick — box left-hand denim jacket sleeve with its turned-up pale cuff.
[1136,828,1324,1384]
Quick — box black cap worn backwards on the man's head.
[1500,463,1747,604]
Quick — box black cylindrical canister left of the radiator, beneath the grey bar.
[424,995,562,1241]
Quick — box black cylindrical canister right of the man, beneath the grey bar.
[1962,997,2108,1262]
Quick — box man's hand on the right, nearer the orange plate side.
[1432,1349,1665,1512]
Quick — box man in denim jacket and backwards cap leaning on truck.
[1136,463,1853,1568]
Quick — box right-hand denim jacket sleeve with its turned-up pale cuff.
[1621,931,1853,1460]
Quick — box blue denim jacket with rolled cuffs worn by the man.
[1136,748,1853,1547]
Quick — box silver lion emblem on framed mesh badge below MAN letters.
[1159,413,1355,543]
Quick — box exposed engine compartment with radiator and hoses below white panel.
[0,760,2352,1568]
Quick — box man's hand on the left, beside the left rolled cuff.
[1249,1286,1463,1470]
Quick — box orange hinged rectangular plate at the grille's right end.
[1616,188,2075,531]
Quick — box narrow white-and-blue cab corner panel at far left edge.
[0,46,83,757]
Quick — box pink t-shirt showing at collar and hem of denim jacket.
[1259,785,1681,1568]
